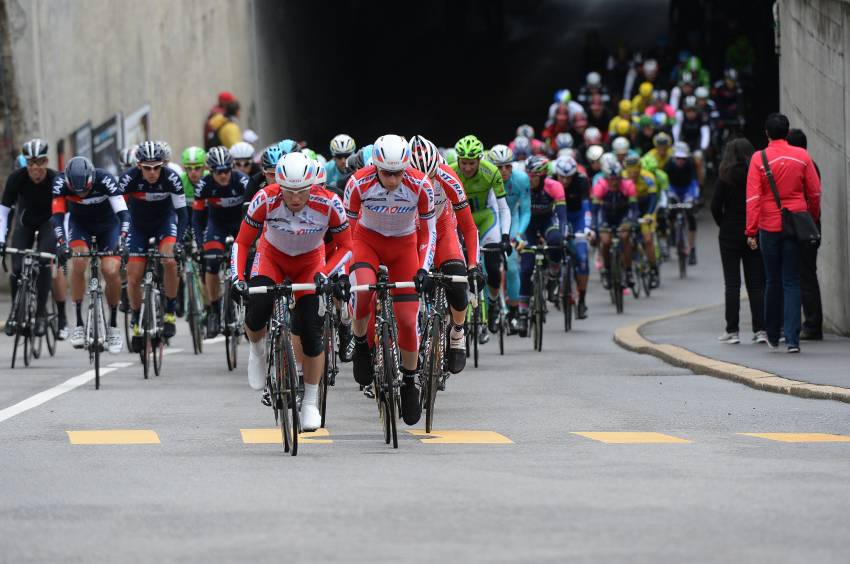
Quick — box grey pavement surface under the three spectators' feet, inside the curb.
[640,302,850,388]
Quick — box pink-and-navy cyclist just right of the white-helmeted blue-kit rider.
[591,160,637,287]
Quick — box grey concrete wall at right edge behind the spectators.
[779,0,850,334]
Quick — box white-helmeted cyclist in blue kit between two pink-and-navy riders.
[555,157,593,319]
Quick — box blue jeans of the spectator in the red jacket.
[759,231,800,347]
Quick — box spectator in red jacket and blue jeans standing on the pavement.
[746,113,820,353]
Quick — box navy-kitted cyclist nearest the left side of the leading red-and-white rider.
[192,148,248,337]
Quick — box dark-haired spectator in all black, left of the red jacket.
[711,138,767,344]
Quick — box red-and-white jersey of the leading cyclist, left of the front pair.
[245,184,348,256]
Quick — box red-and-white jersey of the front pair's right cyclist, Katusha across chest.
[345,165,435,237]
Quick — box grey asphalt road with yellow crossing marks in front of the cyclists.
[0,217,850,563]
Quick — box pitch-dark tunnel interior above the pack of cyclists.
[255,0,778,152]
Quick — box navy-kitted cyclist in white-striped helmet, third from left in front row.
[119,141,188,352]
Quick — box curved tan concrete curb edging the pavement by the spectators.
[614,305,850,403]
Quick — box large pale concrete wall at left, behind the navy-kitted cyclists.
[0,0,257,164]
